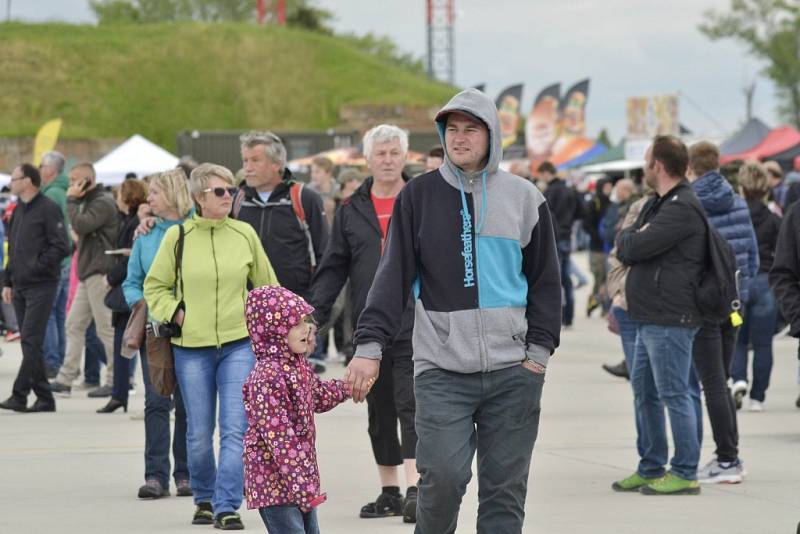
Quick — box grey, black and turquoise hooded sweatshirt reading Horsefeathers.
[355,89,561,375]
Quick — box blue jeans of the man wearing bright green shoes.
[631,324,700,480]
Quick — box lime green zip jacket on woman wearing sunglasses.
[144,215,279,347]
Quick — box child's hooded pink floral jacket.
[242,286,350,512]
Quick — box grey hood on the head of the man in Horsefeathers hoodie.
[436,89,503,175]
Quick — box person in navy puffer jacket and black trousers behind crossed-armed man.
[688,141,759,484]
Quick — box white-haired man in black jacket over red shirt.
[311,124,419,523]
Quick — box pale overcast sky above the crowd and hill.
[6,0,779,141]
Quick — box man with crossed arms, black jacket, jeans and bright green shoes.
[612,136,707,495]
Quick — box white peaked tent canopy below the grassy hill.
[94,134,178,185]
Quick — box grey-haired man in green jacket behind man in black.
[39,151,72,378]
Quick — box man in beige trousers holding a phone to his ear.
[51,163,119,397]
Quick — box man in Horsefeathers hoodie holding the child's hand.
[346,89,561,534]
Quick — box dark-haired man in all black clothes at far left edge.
[0,163,69,412]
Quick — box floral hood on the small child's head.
[245,286,314,360]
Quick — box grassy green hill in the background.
[0,23,453,148]
